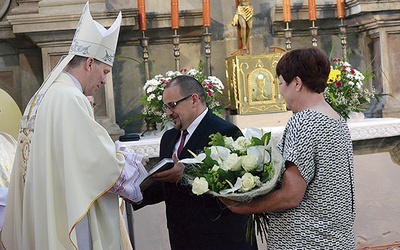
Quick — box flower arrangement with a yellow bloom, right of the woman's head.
[324,58,381,119]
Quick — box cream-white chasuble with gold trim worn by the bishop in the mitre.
[2,73,130,250]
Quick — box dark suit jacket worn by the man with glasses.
[138,110,257,250]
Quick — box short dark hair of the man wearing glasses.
[165,75,206,104]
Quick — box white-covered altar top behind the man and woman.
[115,118,400,165]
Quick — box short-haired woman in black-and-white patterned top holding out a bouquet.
[222,48,355,249]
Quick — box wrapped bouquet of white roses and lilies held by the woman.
[181,128,283,242]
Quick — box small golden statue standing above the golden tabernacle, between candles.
[232,0,254,54]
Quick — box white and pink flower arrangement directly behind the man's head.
[124,62,224,125]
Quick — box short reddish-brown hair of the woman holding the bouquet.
[276,47,331,93]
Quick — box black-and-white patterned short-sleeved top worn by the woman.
[267,110,355,250]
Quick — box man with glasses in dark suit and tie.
[137,75,257,250]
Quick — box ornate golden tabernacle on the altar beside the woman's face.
[225,51,286,115]
